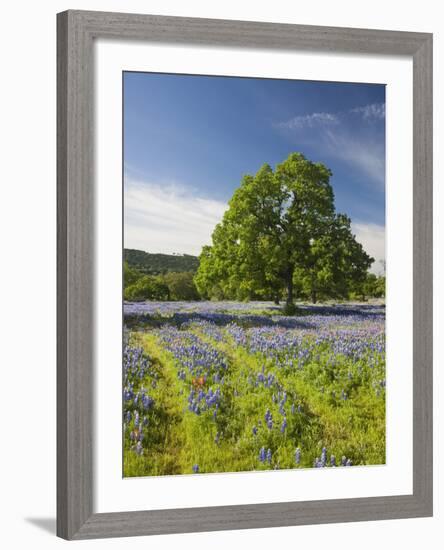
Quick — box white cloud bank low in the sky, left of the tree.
[124,177,227,255]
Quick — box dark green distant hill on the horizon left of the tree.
[123,248,199,275]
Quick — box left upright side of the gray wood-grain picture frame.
[57,13,94,538]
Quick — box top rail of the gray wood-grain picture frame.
[70,11,428,55]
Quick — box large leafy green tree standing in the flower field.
[195,153,373,304]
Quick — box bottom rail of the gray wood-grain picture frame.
[74,495,430,540]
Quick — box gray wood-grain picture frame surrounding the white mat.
[57,11,433,539]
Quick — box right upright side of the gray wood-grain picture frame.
[413,36,433,515]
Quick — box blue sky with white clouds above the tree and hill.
[123,72,385,272]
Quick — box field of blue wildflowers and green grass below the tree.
[123,301,385,477]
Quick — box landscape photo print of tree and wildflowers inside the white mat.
[122,72,386,477]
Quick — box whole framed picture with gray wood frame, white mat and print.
[57,11,433,539]
